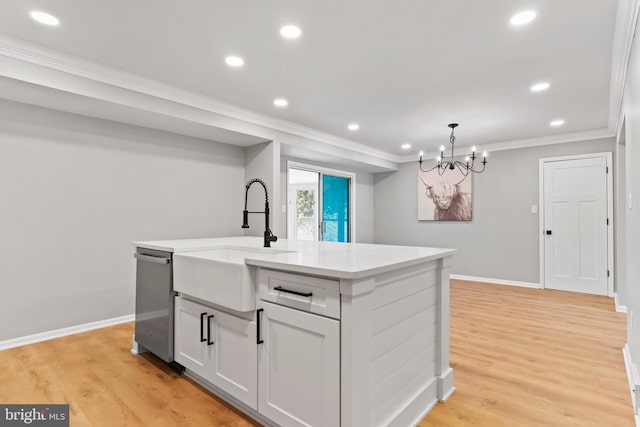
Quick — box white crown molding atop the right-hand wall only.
[609,0,640,130]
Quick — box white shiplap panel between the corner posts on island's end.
[370,261,438,426]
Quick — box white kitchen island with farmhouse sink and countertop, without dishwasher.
[134,237,455,427]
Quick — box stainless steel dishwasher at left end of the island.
[135,248,175,363]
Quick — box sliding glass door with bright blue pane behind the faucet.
[287,162,355,242]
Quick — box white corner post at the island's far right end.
[436,256,455,402]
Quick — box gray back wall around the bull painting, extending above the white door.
[374,138,615,283]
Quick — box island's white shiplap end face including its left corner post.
[341,260,448,426]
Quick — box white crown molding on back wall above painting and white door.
[400,128,615,163]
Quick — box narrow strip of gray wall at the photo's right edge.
[619,11,640,372]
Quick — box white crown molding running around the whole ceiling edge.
[0,33,624,170]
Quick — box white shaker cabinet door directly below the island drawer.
[258,301,340,427]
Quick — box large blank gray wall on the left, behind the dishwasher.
[0,101,244,341]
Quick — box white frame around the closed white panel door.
[538,151,615,297]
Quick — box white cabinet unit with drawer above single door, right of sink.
[258,268,340,426]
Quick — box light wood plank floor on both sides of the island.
[0,281,634,427]
